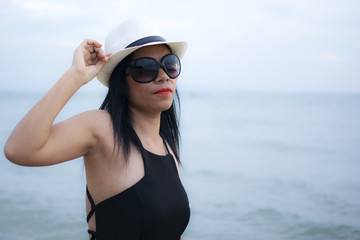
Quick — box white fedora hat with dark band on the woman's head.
[97,17,187,87]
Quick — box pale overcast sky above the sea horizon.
[0,0,360,92]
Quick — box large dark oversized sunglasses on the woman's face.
[125,54,181,83]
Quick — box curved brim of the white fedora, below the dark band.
[97,41,187,87]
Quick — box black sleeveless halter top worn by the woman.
[86,138,190,240]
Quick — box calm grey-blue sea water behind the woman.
[0,92,360,240]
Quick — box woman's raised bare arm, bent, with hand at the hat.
[4,40,110,166]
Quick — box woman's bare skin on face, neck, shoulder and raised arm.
[4,40,182,239]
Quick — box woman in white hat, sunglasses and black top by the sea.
[5,18,190,240]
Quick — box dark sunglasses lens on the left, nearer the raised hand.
[131,58,158,83]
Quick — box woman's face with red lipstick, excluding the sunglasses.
[126,45,177,116]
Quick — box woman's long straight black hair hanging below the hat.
[100,50,180,163]
